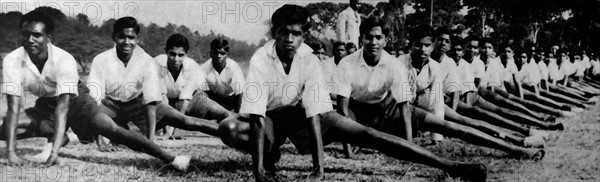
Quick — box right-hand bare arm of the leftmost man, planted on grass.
[46,93,72,165]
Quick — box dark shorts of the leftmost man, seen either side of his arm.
[25,83,98,143]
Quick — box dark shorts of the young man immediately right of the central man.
[348,94,423,135]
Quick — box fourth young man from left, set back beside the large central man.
[201,38,245,112]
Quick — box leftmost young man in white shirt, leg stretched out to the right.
[2,10,189,171]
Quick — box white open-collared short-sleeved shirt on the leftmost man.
[2,44,79,97]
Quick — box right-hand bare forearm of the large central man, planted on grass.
[308,115,325,180]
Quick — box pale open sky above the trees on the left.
[0,0,387,43]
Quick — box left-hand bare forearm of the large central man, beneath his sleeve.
[250,114,265,181]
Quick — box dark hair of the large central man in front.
[271,4,310,37]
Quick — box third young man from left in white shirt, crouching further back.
[154,34,234,139]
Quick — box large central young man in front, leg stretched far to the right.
[219,4,486,181]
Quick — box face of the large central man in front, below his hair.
[275,24,304,57]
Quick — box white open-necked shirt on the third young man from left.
[154,54,208,100]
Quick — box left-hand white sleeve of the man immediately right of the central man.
[332,59,353,98]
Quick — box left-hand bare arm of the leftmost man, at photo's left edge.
[2,94,24,164]
